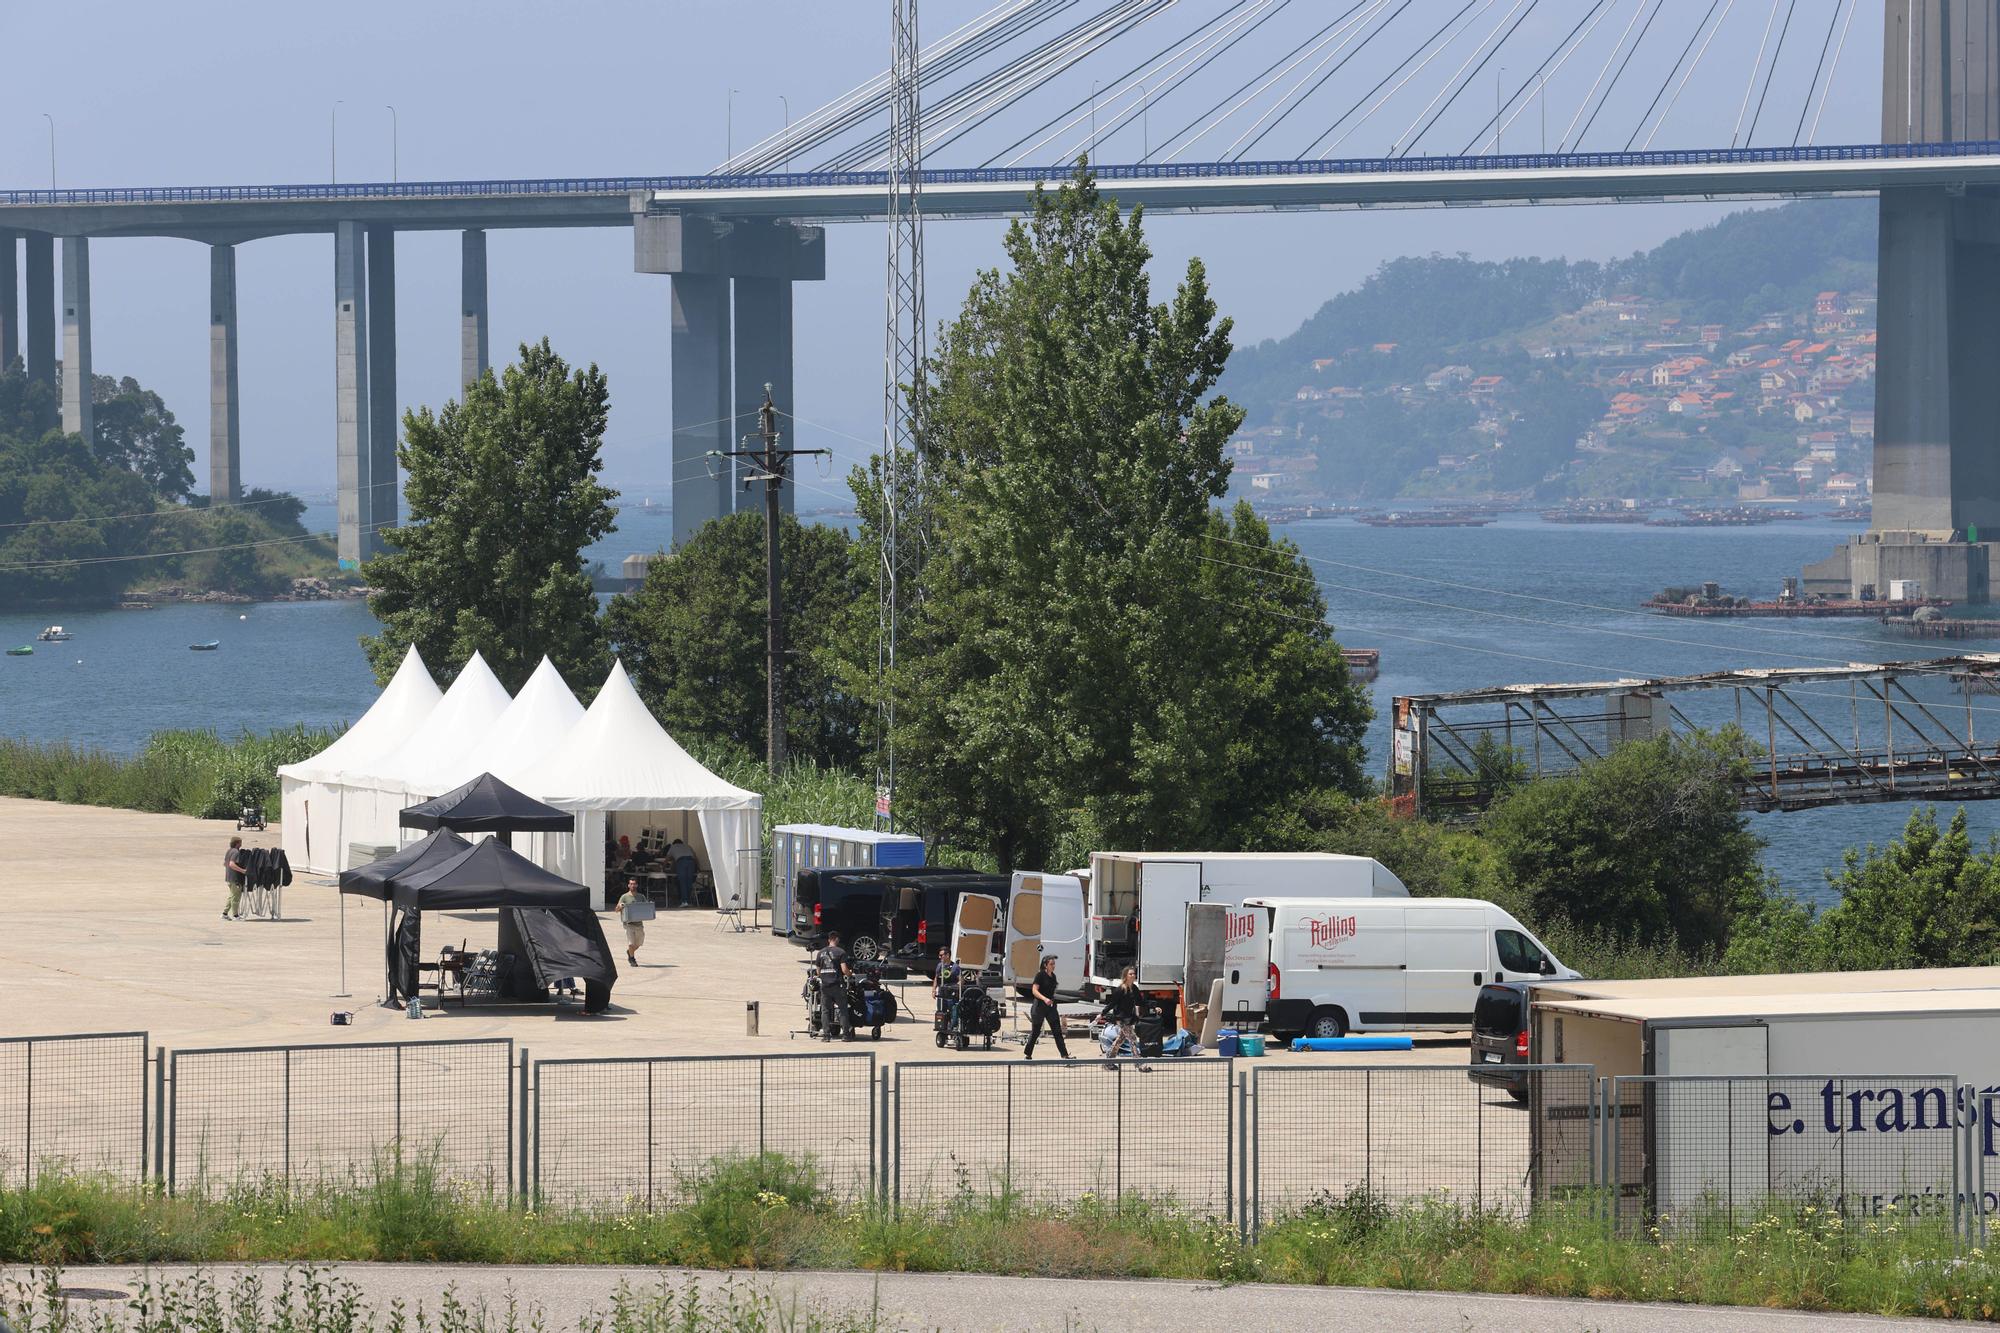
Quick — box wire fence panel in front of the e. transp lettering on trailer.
[1608,1075,1980,1227]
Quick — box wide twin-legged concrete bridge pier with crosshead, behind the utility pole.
[632,214,826,544]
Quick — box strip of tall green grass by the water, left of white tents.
[0,727,340,819]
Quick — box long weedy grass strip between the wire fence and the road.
[0,1155,2000,1327]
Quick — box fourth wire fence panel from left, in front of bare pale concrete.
[888,1059,1238,1217]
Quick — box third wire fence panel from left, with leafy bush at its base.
[530,1051,876,1209]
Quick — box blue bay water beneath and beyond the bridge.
[0,506,2000,893]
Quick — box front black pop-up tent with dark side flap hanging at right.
[388,831,618,1013]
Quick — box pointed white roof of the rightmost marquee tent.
[530,662,762,811]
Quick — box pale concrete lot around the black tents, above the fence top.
[0,799,1466,1067]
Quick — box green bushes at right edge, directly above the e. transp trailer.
[1724,807,2000,973]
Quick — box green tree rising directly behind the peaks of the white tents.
[362,338,618,693]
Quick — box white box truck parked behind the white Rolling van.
[1088,853,1400,984]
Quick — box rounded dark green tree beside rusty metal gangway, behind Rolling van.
[1484,729,1766,953]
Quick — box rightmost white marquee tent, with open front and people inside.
[536,662,764,909]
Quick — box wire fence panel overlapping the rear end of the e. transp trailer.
[1244,1065,1594,1231]
